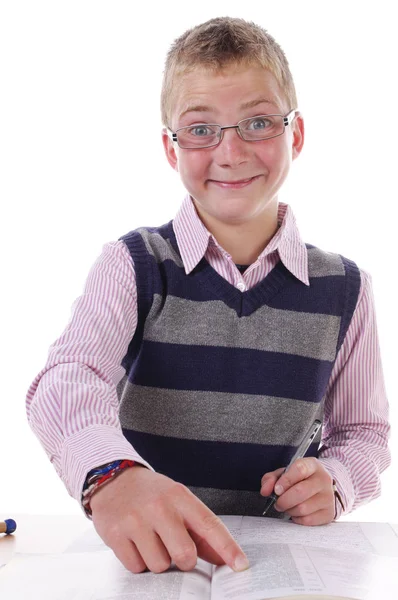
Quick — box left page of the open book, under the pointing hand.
[0,550,213,600]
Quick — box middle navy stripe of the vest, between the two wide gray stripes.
[128,340,333,402]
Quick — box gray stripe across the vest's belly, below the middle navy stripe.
[118,377,323,446]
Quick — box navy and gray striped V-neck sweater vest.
[117,221,360,516]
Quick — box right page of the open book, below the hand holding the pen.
[211,543,398,600]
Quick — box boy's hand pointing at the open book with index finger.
[90,465,249,573]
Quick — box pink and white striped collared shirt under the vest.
[26,195,391,518]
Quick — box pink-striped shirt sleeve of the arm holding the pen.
[319,269,391,519]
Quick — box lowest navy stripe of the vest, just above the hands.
[123,429,318,493]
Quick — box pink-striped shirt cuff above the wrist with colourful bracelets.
[61,425,154,503]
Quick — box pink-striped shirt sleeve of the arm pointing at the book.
[26,240,153,502]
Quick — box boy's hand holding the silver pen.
[260,457,335,525]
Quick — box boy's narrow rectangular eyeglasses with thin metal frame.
[167,108,298,149]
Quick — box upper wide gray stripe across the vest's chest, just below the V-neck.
[144,294,340,361]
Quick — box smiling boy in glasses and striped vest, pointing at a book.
[27,18,390,573]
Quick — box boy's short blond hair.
[160,17,297,128]
